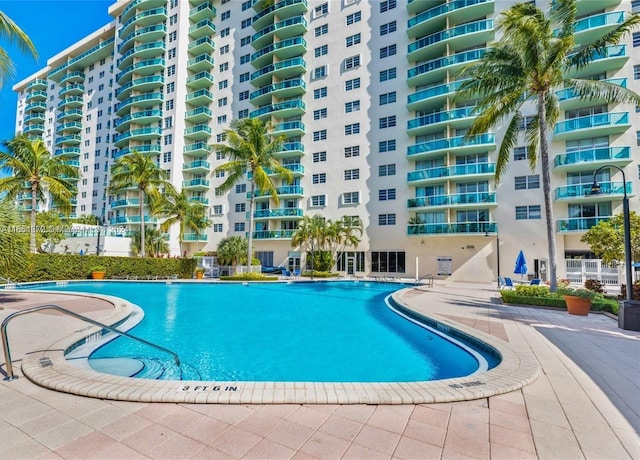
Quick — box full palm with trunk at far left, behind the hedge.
[0,134,78,253]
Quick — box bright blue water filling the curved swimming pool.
[30,282,497,382]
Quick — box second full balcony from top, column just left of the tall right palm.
[407,19,493,62]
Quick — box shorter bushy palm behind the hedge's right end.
[151,187,211,254]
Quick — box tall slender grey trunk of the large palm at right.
[538,93,558,292]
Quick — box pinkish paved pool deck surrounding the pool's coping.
[0,282,640,459]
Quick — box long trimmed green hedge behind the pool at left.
[1,254,196,282]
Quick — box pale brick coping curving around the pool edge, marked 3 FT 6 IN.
[22,288,540,404]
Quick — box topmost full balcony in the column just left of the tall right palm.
[407,0,494,38]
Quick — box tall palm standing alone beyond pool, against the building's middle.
[213,118,293,265]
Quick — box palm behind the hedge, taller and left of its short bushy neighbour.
[109,149,170,257]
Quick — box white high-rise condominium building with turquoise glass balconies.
[14,0,640,281]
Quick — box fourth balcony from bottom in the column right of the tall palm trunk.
[553,112,631,141]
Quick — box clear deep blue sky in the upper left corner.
[0,0,115,141]
